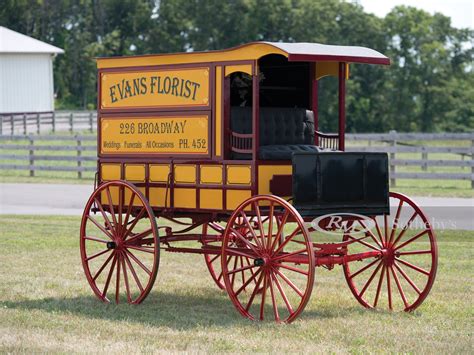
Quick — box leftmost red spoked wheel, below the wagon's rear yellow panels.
[80,181,160,303]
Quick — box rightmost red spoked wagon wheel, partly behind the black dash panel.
[344,192,438,312]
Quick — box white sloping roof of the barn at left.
[0,26,64,54]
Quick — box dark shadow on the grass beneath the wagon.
[0,290,364,330]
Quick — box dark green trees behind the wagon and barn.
[0,0,474,132]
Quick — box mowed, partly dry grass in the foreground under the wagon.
[0,216,474,353]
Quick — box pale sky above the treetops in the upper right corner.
[358,0,474,29]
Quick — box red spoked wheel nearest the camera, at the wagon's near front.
[221,195,315,322]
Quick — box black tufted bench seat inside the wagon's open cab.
[230,107,318,160]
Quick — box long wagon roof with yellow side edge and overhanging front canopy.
[97,42,390,68]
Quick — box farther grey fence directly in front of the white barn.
[0,111,97,135]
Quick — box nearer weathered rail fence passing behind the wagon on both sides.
[0,132,474,188]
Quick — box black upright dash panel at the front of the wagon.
[293,152,389,216]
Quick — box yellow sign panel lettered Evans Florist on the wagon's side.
[100,68,209,109]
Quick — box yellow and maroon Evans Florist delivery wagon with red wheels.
[80,42,437,322]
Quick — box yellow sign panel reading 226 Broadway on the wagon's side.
[100,115,209,155]
